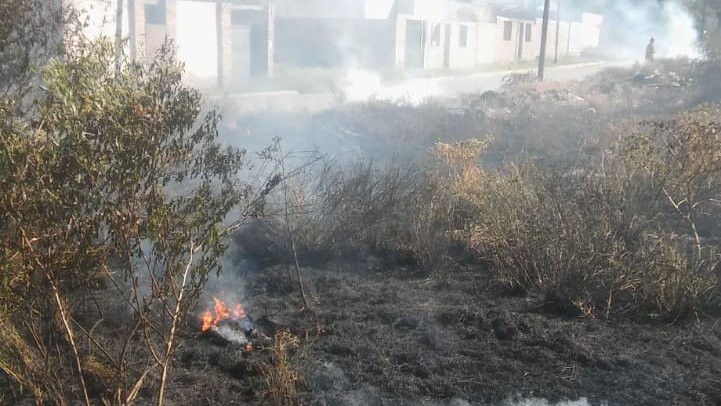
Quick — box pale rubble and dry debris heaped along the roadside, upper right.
[462,60,705,119]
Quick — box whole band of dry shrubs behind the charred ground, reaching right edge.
[266,109,721,320]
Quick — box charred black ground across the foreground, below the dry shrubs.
[168,257,721,406]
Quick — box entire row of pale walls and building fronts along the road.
[70,0,602,86]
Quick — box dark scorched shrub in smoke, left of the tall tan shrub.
[272,162,450,269]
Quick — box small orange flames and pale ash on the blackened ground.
[200,298,256,351]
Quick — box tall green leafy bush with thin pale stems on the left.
[0,42,247,404]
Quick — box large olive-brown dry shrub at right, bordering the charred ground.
[469,169,718,319]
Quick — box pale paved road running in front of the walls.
[214,62,624,114]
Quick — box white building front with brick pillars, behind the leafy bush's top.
[64,0,270,86]
